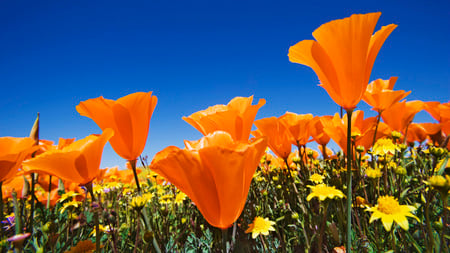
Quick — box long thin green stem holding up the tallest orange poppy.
[346,109,353,253]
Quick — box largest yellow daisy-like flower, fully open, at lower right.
[366,196,419,231]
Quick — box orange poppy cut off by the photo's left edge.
[0,137,38,182]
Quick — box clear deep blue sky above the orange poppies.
[0,0,450,168]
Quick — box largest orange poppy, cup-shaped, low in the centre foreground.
[150,131,267,228]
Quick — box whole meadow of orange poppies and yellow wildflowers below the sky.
[0,13,450,252]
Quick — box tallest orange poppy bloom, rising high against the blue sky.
[289,12,397,110]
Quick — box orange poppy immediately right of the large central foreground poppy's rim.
[252,117,294,160]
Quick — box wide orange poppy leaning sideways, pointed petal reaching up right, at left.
[23,128,114,185]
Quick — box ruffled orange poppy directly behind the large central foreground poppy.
[183,96,266,142]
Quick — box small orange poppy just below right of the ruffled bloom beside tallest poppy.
[381,100,424,134]
